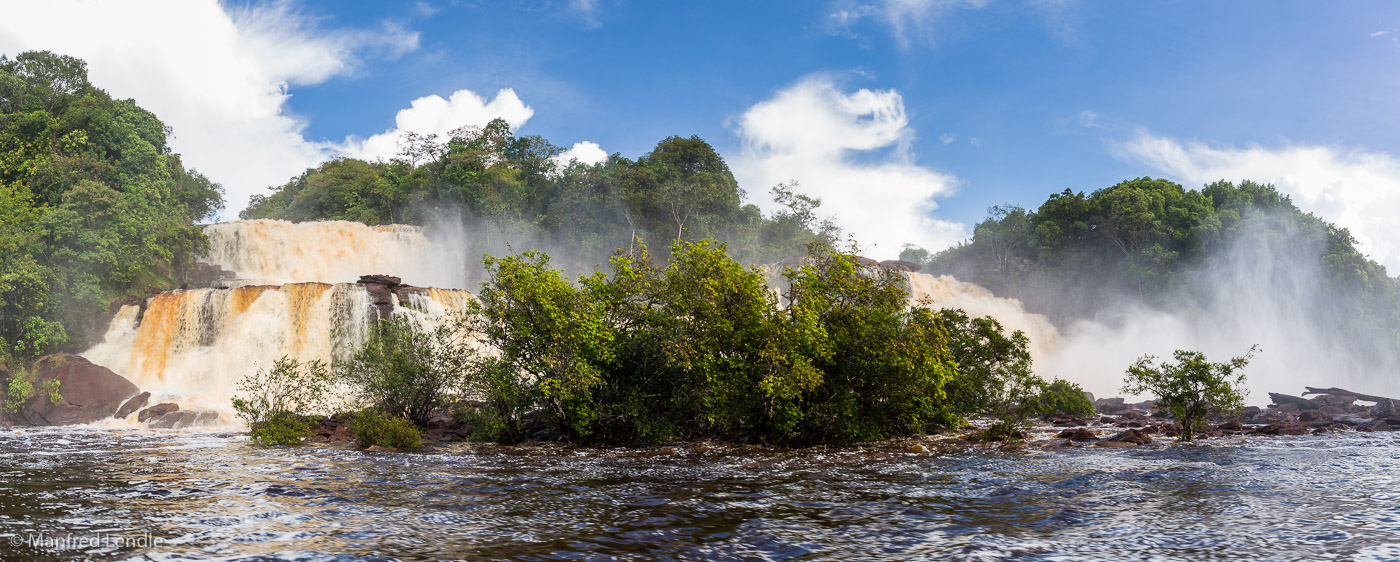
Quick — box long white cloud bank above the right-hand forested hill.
[1119,132,1400,272]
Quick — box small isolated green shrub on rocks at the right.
[1123,346,1259,441]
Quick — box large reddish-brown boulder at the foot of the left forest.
[20,353,141,426]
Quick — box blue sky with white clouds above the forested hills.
[0,0,1400,262]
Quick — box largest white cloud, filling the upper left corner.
[0,0,419,217]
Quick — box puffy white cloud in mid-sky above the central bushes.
[729,76,967,258]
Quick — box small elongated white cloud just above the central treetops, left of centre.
[326,88,534,160]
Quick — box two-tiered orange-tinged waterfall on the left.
[83,220,472,420]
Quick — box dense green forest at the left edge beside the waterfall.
[0,52,223,367]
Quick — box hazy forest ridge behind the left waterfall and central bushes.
[241,119,839,273]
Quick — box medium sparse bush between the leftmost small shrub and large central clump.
[336,311,475,423]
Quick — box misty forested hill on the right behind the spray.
[902,178,1400,366]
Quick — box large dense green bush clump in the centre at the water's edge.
[473,241,956,444]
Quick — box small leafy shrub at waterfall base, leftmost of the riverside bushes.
[234,357,333,444]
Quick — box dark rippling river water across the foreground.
[0,429,1400,561]
